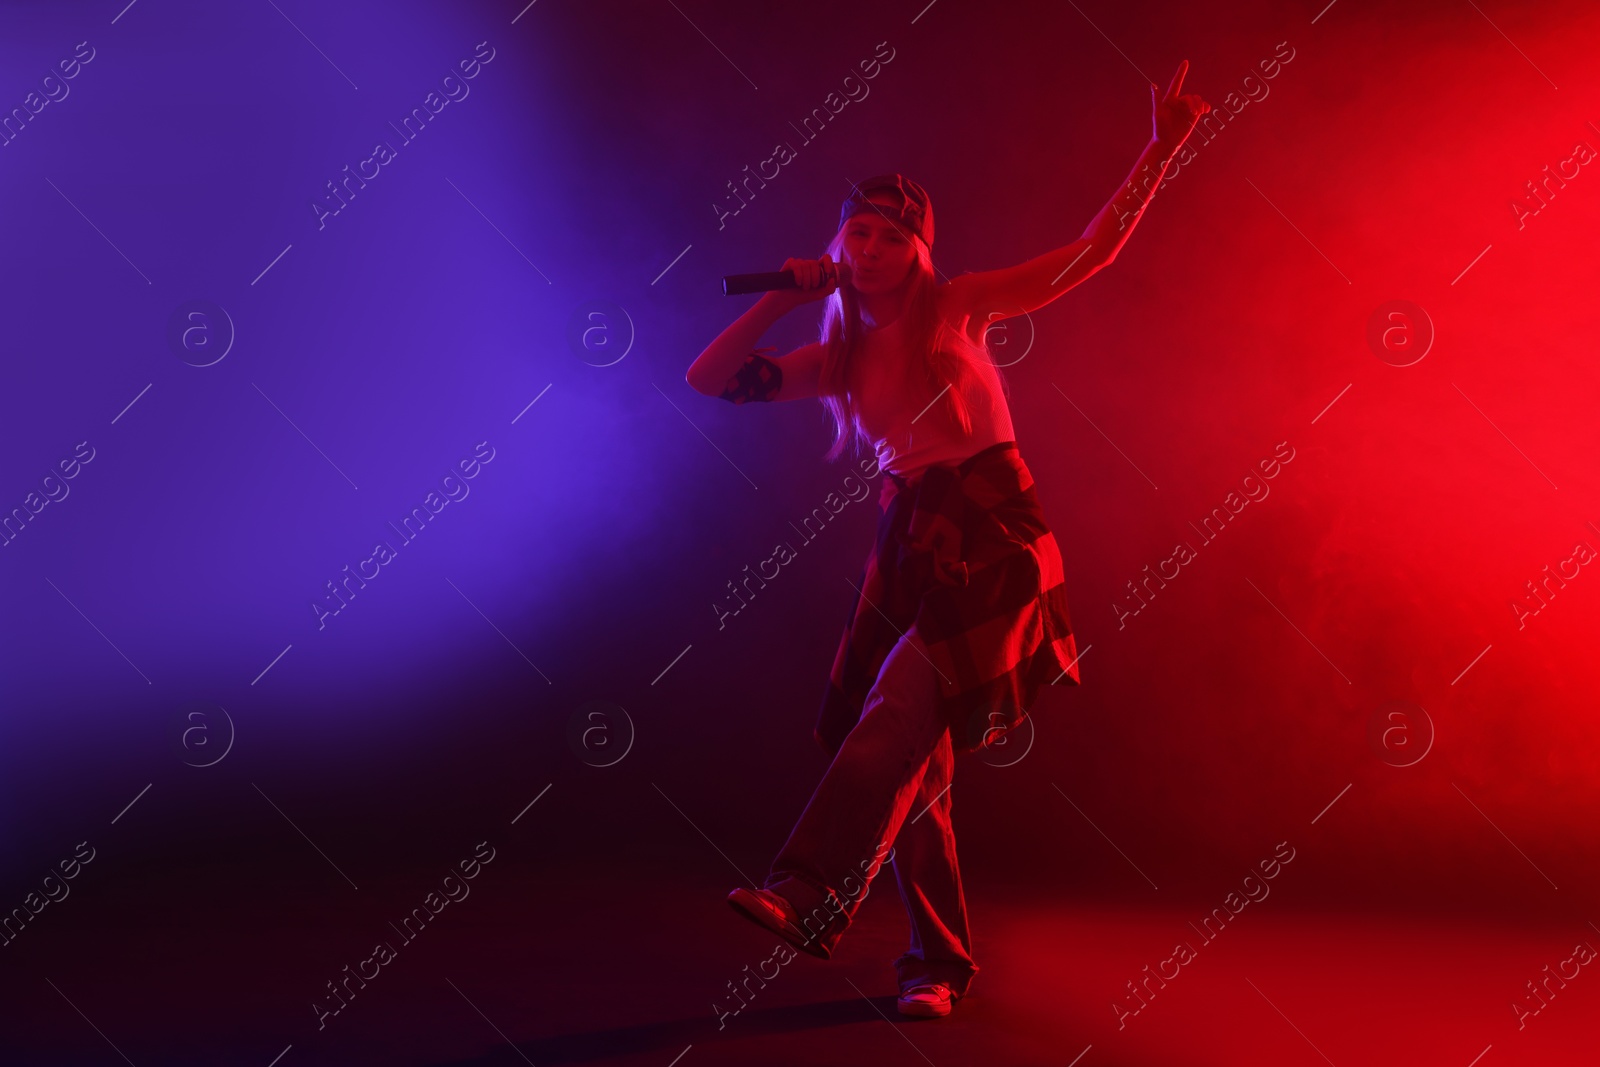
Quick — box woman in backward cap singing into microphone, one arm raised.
[686,59,1210,1016]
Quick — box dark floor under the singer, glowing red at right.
[0,862,1600,1067]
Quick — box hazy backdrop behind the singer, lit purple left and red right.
[0,0,1600,1062]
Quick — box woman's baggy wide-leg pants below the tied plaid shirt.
[765,627,978,997]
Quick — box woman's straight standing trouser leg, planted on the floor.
[893,733,979,997]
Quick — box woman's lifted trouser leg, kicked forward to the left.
[765,627,947,947]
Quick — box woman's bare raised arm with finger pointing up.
[949,59,1211,318]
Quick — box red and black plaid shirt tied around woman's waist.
[814,442,1082,757]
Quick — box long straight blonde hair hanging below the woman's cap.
[818,221,1005,462]
